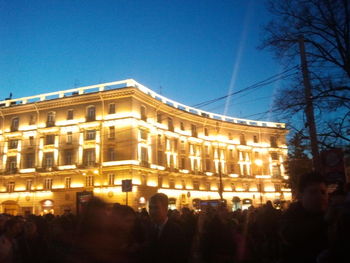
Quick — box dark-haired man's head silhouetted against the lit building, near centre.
[149,193,168,224]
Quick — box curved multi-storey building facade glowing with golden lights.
[0,79,291,214]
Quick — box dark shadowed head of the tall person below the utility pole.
[298,173,328,213]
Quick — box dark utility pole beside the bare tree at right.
[298,35,321,172]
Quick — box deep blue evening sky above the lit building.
[0,0,290,120]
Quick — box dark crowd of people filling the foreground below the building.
[0,174,350,263]
